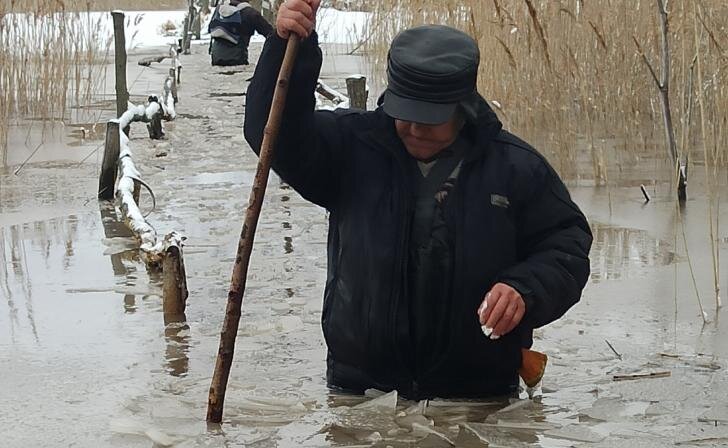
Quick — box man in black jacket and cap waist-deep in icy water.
[245,0,592,399]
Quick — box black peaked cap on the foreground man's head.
[380,25,480,125]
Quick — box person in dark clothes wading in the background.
[209,0,273,66]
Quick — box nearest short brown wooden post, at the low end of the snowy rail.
[162,235,189,316]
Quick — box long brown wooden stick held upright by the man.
[207,34,299,423]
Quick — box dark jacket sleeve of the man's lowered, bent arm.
[499,163,592,328]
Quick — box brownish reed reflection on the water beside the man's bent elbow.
[590,223,678,282]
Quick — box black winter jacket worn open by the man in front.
[245,34,592,399]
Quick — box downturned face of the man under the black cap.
[394,114,462,161]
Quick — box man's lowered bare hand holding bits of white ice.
[478,283,526,339]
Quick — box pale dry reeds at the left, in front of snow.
[0,0,111,166]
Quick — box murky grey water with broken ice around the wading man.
[0,39,728,447]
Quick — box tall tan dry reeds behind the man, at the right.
[367,0,728,184]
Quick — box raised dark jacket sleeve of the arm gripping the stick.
[245,33,343,210]
